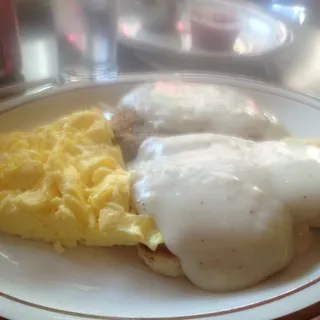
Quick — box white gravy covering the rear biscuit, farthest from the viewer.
[120,82,288,140]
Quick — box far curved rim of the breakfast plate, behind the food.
[0,70,320,115]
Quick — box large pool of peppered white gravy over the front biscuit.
[132,134,320,291]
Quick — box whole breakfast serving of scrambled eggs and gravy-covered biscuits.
[0,82,320,291]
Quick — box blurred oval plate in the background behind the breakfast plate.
[119,0,289,55]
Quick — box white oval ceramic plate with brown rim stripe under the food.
[0,74,320,320]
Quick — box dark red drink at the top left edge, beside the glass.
[0,0,21,78]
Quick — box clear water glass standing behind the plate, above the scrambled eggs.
[51,0,118,82]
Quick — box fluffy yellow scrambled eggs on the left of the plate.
[0,110,162,250]
